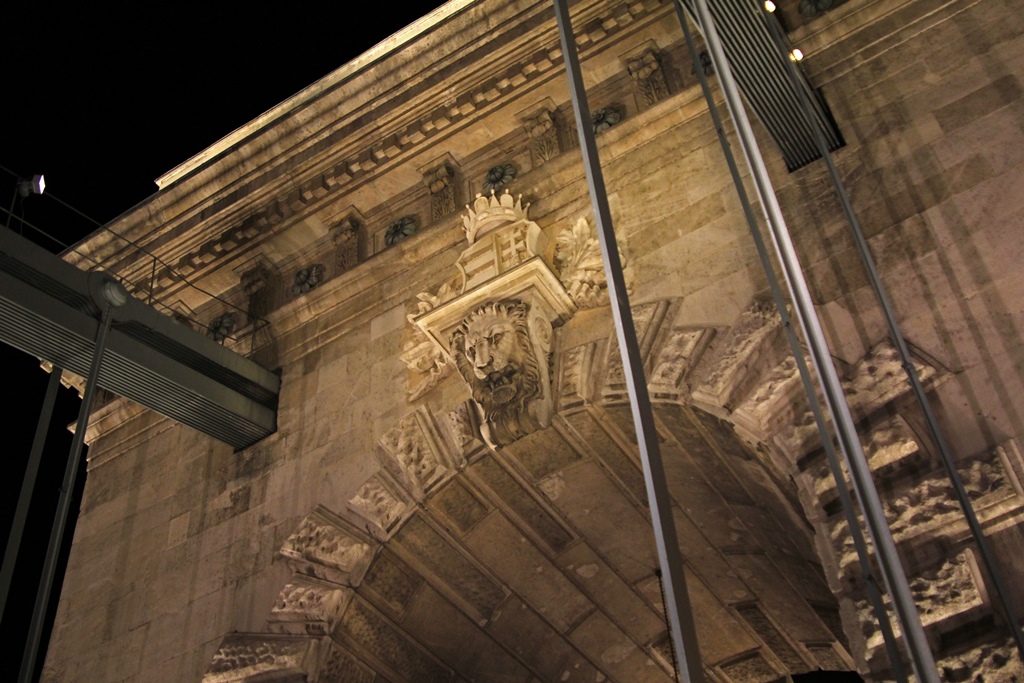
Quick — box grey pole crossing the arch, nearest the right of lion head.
[553,0,703,683]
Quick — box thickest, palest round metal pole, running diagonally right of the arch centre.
[695,0,939,683]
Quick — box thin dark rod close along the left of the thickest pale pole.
[675,5,907,683]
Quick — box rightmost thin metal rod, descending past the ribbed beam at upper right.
[762,9,1024,661]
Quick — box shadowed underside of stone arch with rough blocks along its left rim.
[208,294,864,682]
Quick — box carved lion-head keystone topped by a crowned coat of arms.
[414,191,577,447]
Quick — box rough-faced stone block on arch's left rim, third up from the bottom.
[281,507,374,586]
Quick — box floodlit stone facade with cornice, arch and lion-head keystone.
[44,0,1024,683]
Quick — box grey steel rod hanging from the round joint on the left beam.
[17,303,114,683]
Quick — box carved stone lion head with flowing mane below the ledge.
[449,299,543,445]
